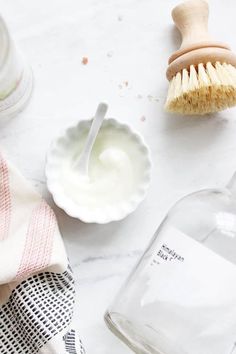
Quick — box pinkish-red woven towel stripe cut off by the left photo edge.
[0,154,11,241]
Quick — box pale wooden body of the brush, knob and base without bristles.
[166,0,236,80]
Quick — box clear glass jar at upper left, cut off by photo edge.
[0,16,33,118]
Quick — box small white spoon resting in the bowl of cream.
[74,102,108,178]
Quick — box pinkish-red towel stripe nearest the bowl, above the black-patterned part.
[16,200,57,279]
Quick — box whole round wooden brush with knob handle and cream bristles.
[165,0,236,115]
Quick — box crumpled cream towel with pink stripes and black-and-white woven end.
[0,155,85,354]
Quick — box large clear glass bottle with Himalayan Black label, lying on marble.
[105,176,236,354]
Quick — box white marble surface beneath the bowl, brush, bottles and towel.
[0,0,236,354]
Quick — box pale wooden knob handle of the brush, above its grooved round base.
[169,0,229,63]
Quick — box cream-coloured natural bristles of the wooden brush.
[165,62,236,114]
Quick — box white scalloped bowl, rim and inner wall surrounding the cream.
[46,119,151,224]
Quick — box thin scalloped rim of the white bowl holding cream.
[45,118,152,224]
